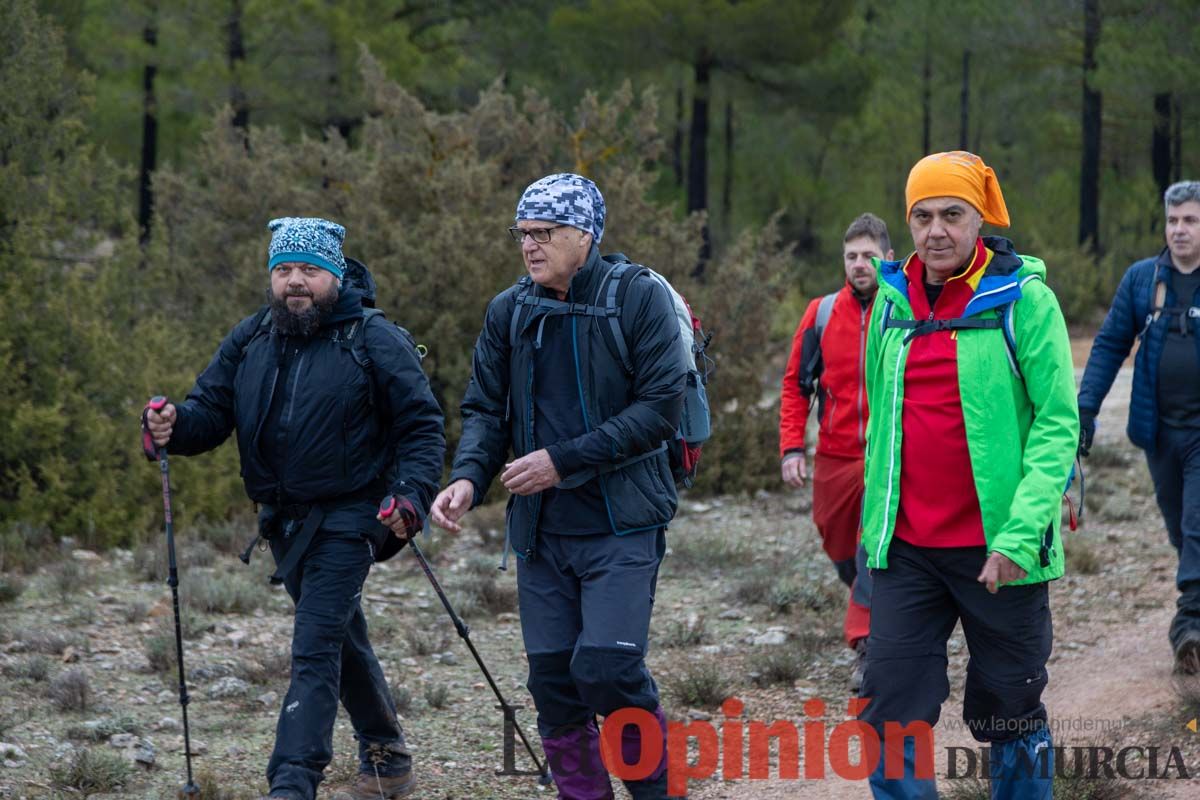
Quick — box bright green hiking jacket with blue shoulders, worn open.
[863,236,1079,585]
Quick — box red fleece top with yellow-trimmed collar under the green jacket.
[895,240,991,547]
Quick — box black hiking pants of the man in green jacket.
[859,539,1052,742]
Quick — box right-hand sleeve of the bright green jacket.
[991,279,1079,572]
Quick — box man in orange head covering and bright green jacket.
[860,151,1079,800]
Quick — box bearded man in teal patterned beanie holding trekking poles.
[146,217,445,800]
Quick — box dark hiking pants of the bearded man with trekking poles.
[266,529,412,800]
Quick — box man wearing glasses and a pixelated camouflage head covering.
[432,173,686,800]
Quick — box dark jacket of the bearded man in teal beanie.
[170,289,445,525]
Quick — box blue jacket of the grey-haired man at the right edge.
[1079,247,1200,453]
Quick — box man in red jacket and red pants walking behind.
[779,213,894,692]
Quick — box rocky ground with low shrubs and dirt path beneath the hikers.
[0,361,1200,800]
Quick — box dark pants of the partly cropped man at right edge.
[1146,423,1200,648]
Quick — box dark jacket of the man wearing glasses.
[450,246,688,558]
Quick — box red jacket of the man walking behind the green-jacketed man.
[779,283,870,458]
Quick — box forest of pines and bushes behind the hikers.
[0,0,1200,570]
